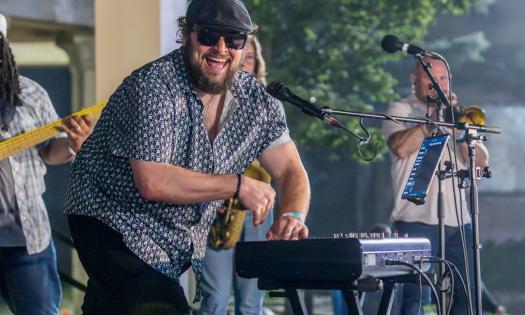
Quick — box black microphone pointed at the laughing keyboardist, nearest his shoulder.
[266,81,342,127]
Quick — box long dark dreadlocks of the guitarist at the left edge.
[0,32,22,130]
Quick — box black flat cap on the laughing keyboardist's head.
[186,0,253,33]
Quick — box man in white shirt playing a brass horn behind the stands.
[383,57,488,315]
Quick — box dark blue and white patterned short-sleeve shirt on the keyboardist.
[66,49,287,298]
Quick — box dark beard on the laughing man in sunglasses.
[182,46,239,94]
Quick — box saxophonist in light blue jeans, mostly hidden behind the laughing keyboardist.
[199,35,273,315]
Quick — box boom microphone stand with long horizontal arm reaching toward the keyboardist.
[321,108,501,315]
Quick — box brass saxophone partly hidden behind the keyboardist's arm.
[208,160,271,249]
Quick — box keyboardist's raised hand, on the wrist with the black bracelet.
[239,176,275,226]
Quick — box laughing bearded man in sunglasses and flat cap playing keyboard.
[66,0,310,314]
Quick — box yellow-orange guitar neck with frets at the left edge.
[0,103,106,160]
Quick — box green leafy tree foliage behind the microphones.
[245,0,478,162]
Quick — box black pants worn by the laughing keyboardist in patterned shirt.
[68,215,191,315]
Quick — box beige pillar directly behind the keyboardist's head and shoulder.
[95,0,186,102]
